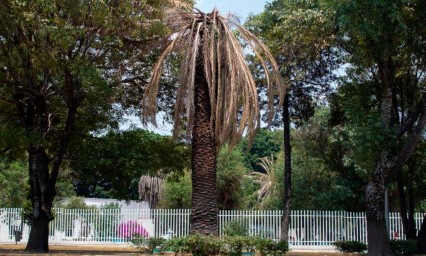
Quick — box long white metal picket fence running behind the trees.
[0,208,423,246]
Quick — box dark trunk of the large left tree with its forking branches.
[22,76,81,252]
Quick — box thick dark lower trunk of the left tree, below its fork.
[25,147,54,252]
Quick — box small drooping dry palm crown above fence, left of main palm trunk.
[138,175,163,208]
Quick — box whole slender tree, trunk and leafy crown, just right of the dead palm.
[248,1,338,240]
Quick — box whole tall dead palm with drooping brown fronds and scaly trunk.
[142,9,283,235]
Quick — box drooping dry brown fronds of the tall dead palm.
[142,10,284,147]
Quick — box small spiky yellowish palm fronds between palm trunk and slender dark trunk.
[250,155,276,201]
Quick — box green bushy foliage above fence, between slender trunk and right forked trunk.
[292,108,368,211]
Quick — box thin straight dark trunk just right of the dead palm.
[280,93,291,241]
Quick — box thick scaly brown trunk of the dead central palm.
[190,41,218,235]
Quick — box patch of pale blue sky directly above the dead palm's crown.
[195,0,271,23]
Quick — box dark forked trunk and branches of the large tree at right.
[366,58,426,256]
